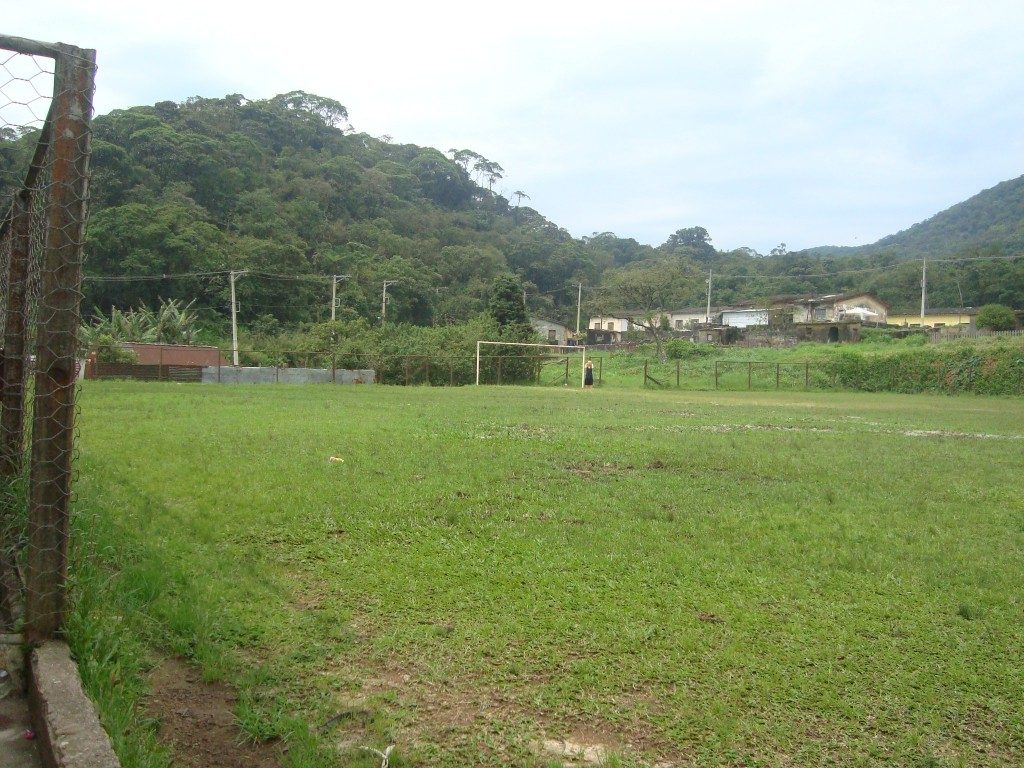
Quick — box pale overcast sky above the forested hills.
[8,0,1024,252]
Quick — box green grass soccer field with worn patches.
[69,383,1024,768]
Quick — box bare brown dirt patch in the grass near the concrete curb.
[145,658,281,768]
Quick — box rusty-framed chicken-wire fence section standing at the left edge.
[0,36,95,641]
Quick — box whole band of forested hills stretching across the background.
[0,91,1024,333]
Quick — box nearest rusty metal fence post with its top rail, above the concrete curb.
[0,38,95,642]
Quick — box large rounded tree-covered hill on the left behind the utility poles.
[77,92,611,331]
